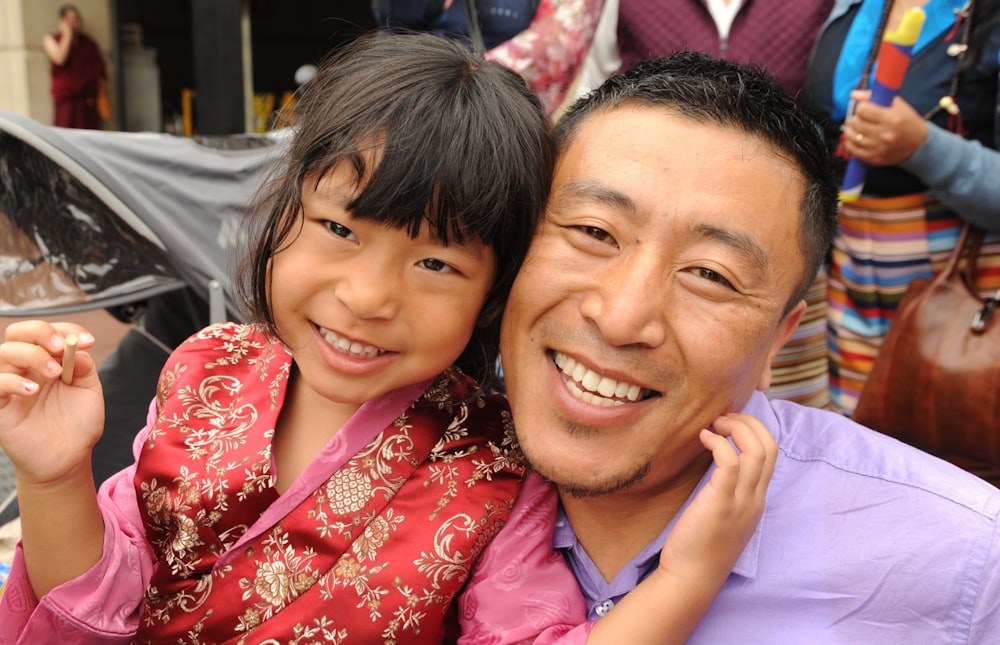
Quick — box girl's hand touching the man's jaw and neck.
[660,414,778,584]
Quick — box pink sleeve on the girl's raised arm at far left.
[0,404,155,645]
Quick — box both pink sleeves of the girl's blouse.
[0,406,592,645]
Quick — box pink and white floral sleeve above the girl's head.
[486,0,603,115]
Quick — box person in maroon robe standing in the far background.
[42,5,107,130]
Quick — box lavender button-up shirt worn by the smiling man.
[553,392,1000,645]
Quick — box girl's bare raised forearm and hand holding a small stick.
[0,321,104,598]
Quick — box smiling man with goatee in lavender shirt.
[466,53,1000,644]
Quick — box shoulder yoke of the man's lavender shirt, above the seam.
[771,401,1000,524]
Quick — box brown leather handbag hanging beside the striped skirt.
[852,224,1000,485]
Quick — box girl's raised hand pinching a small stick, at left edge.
[0,321,104,486]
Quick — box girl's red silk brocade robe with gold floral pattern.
[135,325,523,643]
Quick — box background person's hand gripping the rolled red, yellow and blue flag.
[844,90,928,166]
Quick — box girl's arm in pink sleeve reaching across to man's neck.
[459,414,778,645]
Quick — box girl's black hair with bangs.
[234,31,555,390]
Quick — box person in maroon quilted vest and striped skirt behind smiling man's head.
[577,0,833,408]
